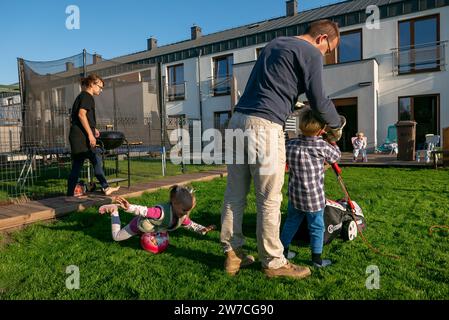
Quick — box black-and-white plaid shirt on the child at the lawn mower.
[287,135,341,212]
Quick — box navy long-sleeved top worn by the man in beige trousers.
[234,37,340,128]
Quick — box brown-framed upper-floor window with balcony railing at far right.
[397,15,443,74]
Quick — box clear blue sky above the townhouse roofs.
[0,0,341,84]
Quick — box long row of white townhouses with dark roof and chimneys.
[15,0,449,151]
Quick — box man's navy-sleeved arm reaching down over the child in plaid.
[304,56,341,128]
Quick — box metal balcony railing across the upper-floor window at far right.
[392,41,447,74]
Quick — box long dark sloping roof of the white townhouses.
[114,0,449,63]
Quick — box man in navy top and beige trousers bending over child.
[220,20,343,279]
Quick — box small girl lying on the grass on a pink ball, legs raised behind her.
[98,185,216,253]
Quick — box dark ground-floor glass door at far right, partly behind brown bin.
[398,95,440,149]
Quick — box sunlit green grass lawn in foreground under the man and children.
[0,168,449,300]
